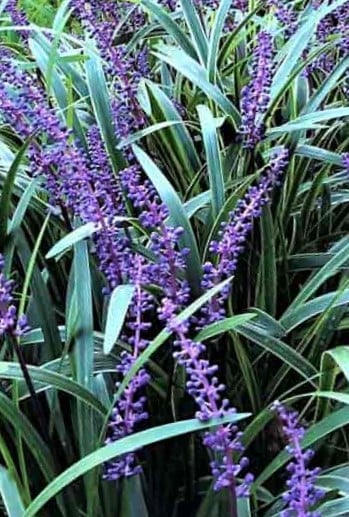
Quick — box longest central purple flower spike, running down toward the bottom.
[118,156,253,496]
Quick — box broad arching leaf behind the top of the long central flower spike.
[132,145,201,296]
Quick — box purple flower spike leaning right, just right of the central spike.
[199,149,288,326]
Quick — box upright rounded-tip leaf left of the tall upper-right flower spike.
[197,105,225,219]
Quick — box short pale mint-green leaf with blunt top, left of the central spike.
[103,285,135,354]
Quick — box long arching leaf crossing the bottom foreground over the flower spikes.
[24,413,249,517]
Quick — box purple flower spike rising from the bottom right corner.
[272,401,324,517]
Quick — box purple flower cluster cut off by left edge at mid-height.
[0,255,29,339]
